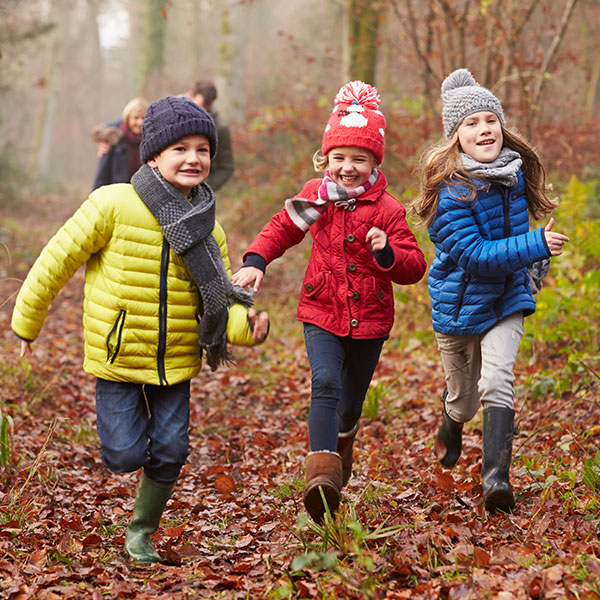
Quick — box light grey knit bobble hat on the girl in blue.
[442,69,504,138]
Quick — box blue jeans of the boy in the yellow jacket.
[96,378,190,485]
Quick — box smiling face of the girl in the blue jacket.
[457,111,503,162]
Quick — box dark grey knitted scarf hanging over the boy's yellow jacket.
[131,164,252,371]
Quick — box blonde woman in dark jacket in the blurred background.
[92,98,148,191]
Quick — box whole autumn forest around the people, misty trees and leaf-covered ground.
[0,0,600,600]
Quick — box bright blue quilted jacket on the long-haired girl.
[428,172,550,335]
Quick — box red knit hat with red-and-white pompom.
[321,81,385,164]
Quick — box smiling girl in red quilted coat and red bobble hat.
[233,81,426,522]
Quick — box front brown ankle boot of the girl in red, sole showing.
[302,450,342,523]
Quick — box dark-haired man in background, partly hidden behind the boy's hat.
[187,80,235,192]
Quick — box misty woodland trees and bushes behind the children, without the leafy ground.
[0,0,600,404]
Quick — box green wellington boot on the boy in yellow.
[125,474,173,564]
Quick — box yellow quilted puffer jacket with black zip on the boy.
[11,183,254,385]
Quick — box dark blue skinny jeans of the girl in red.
[304,323,386,452]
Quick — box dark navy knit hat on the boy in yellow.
[140,96,217,163]
